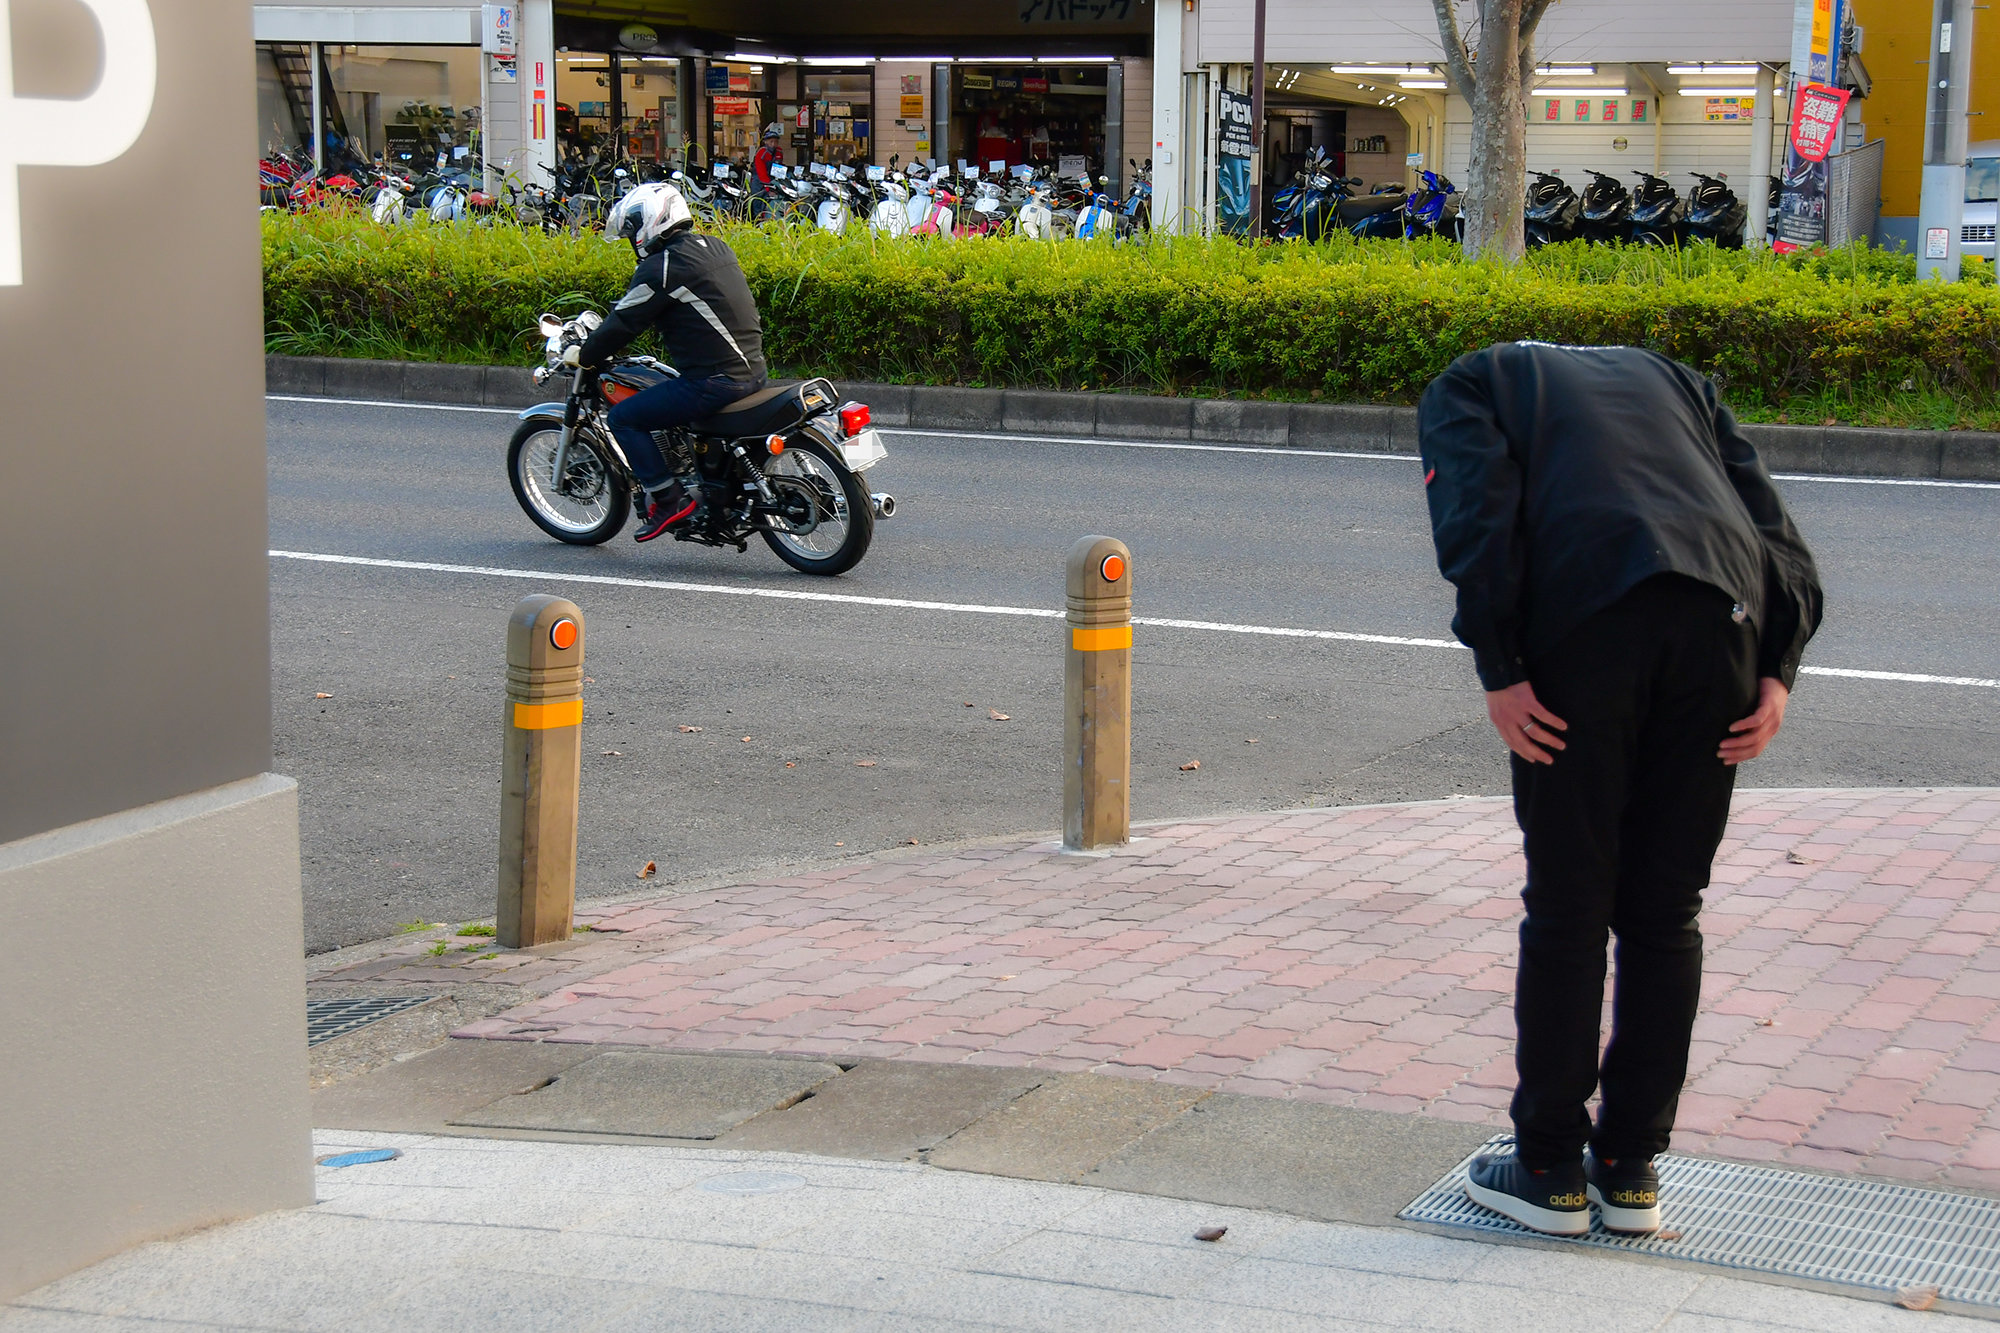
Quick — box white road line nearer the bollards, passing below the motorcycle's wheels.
[270,550,2000,691]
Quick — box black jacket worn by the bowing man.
[1418,342,1822,691]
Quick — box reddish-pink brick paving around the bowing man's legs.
[338,789,2000,1191]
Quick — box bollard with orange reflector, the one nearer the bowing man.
[1062,536,1132,851]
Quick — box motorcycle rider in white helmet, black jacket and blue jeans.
[562,180,764,542]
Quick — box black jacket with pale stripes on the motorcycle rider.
[578,228,764,384]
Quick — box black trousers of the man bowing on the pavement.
[1514,574,1756,1167]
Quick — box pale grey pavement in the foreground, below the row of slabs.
[11,1131,1992,1333]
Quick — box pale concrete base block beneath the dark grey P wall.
[0,772,312,1301]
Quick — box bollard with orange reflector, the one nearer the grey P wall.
[494,592,584,949]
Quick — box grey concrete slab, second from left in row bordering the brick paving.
[452,1051,840,1139]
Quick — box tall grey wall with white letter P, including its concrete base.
[0,0,312,1299]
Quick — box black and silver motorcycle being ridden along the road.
[506,310,896,574]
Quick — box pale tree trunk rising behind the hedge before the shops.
[1432,0,1552,264]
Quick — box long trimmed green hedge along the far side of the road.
[264,214,2000,424]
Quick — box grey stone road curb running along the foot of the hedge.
[264,356,2000,480]
